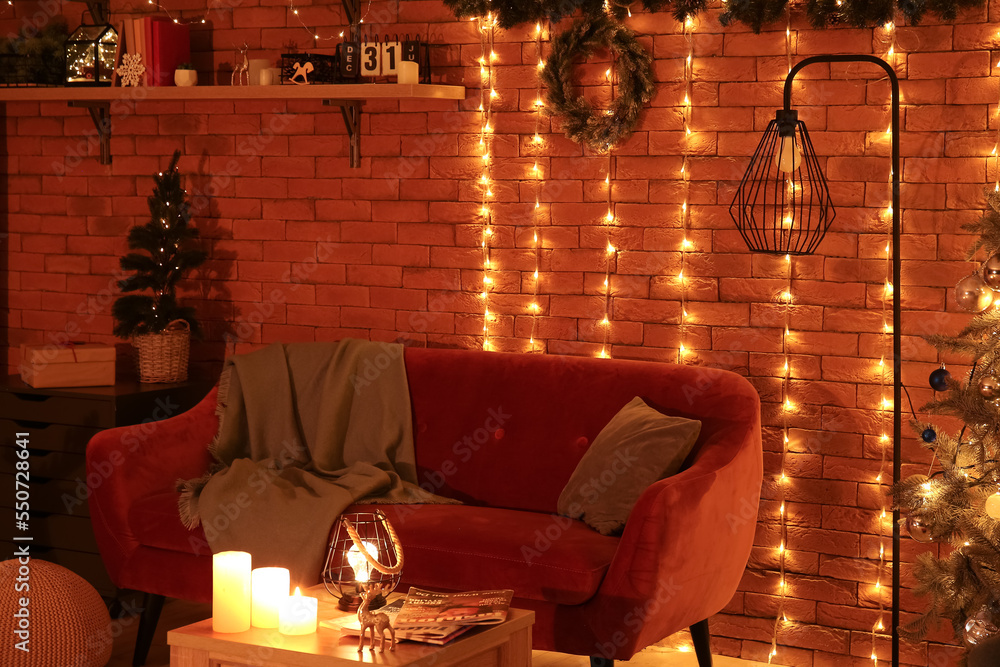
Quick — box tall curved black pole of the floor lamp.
[785,54,903,666]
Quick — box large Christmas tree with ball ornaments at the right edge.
[894,188,1000,652]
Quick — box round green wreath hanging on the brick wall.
[542,14,656,153]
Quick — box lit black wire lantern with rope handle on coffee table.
[323,510,403,611]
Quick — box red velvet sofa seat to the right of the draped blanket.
[347,505,618,605]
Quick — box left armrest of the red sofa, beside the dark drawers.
[87,388,218,582]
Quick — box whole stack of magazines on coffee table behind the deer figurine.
[322,588,514,644]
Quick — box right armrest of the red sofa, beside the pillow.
[588,418,763,659]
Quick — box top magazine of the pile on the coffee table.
[393,588,514,628]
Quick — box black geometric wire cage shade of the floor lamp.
[729,110,837,255]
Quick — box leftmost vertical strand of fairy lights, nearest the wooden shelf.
[478,12,497,350]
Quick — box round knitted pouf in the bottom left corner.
[0,558,111,667]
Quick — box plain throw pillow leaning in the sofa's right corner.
[557,396,701,535]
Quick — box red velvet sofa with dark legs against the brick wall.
[87,348,762,664]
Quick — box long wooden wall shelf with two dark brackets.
[0,83,465,167]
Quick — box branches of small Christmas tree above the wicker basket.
[111,151,207,338]
